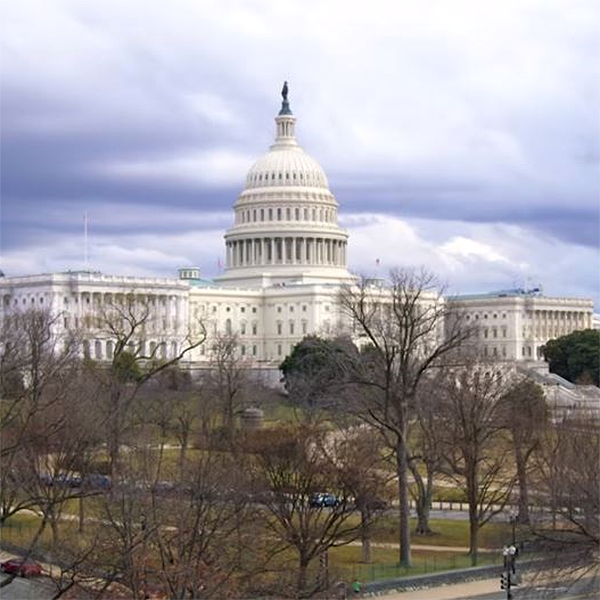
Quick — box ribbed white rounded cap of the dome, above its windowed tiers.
[246,146,329,189]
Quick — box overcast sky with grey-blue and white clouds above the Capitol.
[0,0,600,302]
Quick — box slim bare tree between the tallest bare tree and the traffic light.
[440,361,514,565]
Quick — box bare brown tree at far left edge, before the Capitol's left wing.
[0,310,79,524]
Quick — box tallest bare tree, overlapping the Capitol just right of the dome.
[339,270,469,566]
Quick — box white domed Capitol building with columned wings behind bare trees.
[0,89,597,414]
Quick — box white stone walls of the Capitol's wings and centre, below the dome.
[0,273,593,366]
